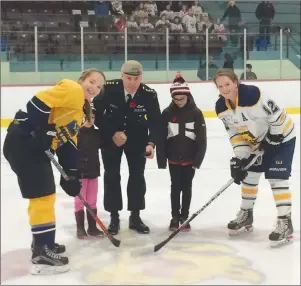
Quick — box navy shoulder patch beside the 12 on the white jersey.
[238,84,260,107]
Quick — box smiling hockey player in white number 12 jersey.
[213,69,296,247]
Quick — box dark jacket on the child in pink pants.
[77,126,103,179]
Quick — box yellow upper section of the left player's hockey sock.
[28,194,56,225]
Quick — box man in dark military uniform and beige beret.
[93,60,161,234]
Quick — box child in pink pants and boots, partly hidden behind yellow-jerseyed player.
[74,111,103,239]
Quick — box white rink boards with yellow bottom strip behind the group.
[1,80,300,127]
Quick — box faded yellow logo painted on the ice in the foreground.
[69,232,263,285]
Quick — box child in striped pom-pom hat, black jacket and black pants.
[157,74,207,231]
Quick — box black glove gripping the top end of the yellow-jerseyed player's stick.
[31,124,57,151]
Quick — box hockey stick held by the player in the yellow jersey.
[45,150,121,247]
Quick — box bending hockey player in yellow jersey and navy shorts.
[3,69,105,274]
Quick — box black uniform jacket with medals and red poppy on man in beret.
[93,80,161,152]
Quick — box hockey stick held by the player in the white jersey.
[154,151,263,252]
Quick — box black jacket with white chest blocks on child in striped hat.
[156,95,207,169]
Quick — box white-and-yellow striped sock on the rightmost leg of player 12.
[269,179,292,216]
